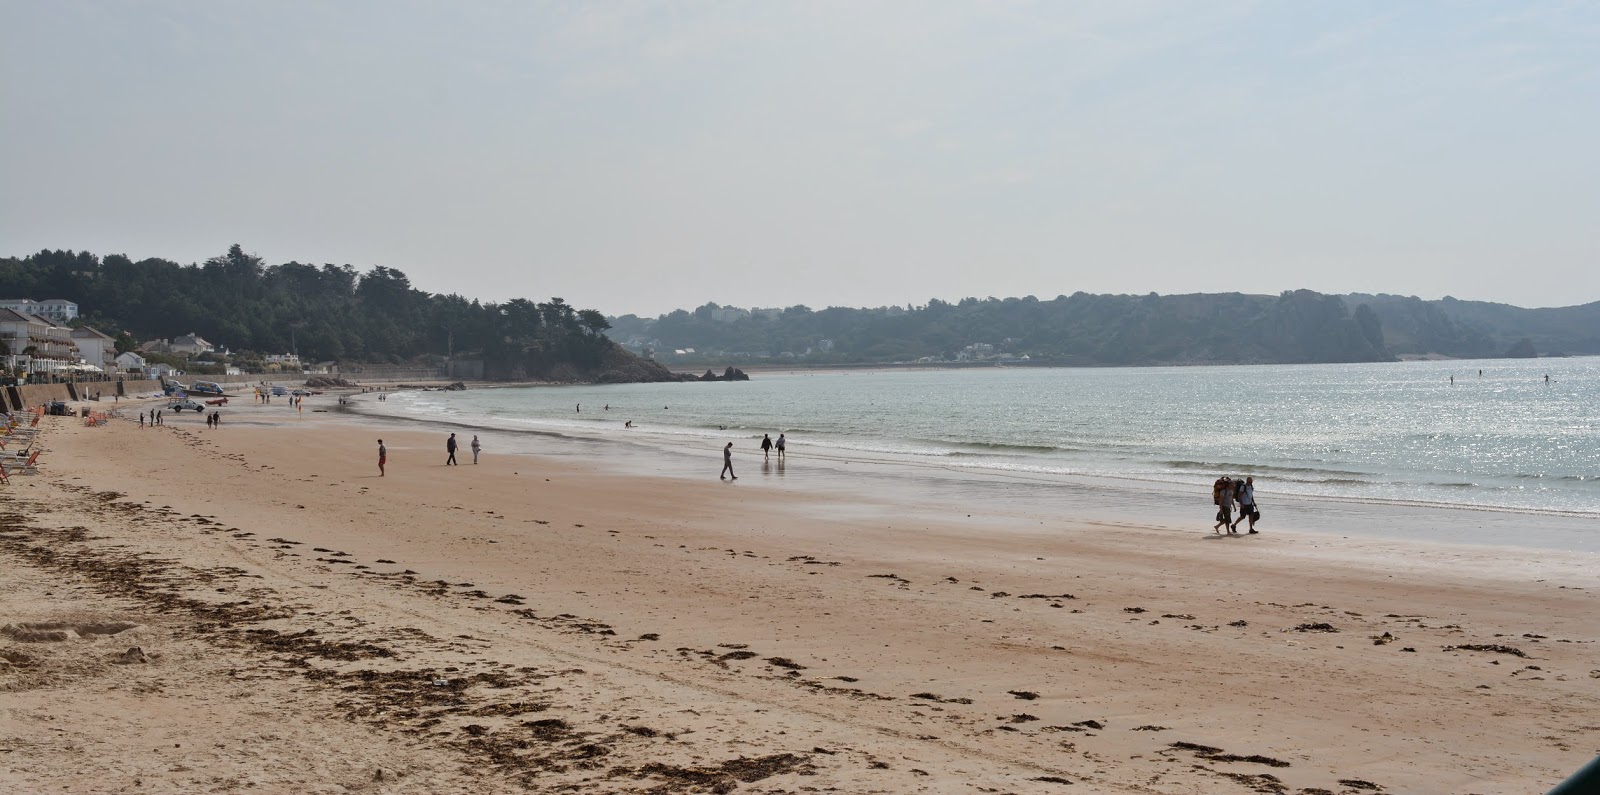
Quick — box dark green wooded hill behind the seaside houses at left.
[0,243,619,378]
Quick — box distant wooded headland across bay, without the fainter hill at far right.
[610,290,1392,365]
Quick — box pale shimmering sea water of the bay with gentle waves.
[368,357,1600,520]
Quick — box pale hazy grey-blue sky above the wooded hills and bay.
[0,0,1600,315]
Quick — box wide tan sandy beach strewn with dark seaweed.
[0,397,1600,795]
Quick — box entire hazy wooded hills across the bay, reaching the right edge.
[608,290,1600,365]
